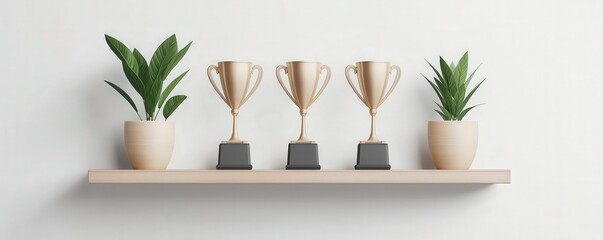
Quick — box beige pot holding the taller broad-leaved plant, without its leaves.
[124,121,174,169]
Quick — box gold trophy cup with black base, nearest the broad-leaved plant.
[207,61,263,169]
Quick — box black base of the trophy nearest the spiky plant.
[354,143,392,170]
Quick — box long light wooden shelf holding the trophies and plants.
[88,169,511,184]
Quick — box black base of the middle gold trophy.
[285,143,320,170]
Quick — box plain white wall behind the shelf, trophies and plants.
[0,0,603,239]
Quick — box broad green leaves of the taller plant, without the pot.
[105,34,193,121]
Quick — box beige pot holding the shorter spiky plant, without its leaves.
[427,121,478,170]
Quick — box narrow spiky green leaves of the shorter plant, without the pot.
[421,52,486,121]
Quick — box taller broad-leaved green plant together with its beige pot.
[105,34,192,169]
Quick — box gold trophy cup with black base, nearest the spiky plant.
[345,61,401,170]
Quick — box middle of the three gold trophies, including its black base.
[276,61,331,170]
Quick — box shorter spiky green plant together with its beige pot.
[423,52,485,169]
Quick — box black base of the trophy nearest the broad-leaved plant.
[216,143,253,170]
